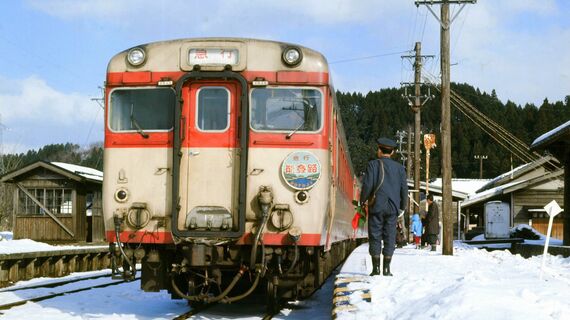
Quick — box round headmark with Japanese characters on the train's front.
[281,151,321,190]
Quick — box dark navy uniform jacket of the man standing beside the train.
[360,158,408,213]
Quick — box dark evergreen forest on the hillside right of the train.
[337,83,570,178]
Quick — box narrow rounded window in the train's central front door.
[196,87,230,131]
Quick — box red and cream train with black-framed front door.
[103,38,366,305]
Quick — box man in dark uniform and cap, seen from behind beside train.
[360,138,408,276]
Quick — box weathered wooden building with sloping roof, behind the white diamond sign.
[461,156,564,239]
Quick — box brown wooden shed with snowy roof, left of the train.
[1,161,105,242]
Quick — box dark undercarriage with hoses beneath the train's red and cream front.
[111,240,359,312]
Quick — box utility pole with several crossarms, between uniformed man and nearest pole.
[402,42,433,216]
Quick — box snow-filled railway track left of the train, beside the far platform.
[0,273,140,310]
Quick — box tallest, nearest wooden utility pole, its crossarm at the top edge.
[415,0,477,255]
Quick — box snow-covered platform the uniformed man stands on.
[333,242,570,320]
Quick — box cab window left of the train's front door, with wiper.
[109,88,176,135]
